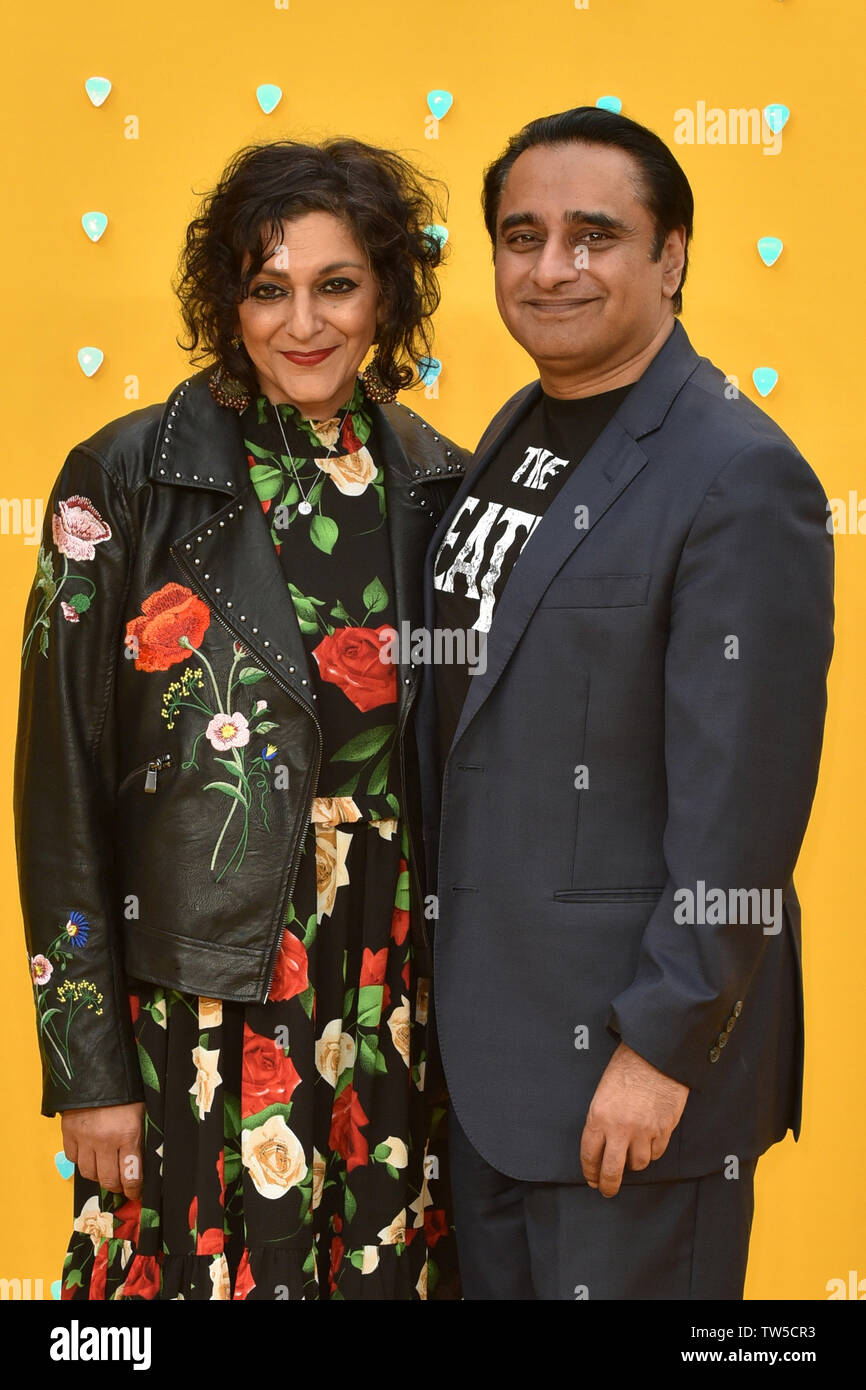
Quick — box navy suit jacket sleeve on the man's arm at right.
[609,443,833,1088]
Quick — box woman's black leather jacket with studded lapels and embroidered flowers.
[14,371,470,1115]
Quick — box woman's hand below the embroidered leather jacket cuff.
[60,1101,145,1200]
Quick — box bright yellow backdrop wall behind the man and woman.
[0,0,866,1300]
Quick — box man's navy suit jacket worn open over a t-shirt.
[417,321,833,1182]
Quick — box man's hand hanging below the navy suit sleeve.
[580,1043,688,1197]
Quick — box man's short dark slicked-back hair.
[481,106,695,314]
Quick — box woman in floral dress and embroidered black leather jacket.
[15,140,467,1300]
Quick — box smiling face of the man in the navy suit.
[495,143,684,379]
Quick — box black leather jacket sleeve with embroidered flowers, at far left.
[14,446,143,1116]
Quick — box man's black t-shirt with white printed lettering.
[434,385,631,765]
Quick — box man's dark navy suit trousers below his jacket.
[449,1109,758,1300]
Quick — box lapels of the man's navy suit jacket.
[425,320,701,748]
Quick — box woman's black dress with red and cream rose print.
[63,379,456,1300]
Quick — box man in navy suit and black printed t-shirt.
[420,107,833,1300]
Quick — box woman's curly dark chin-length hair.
[172,139,448,395]
